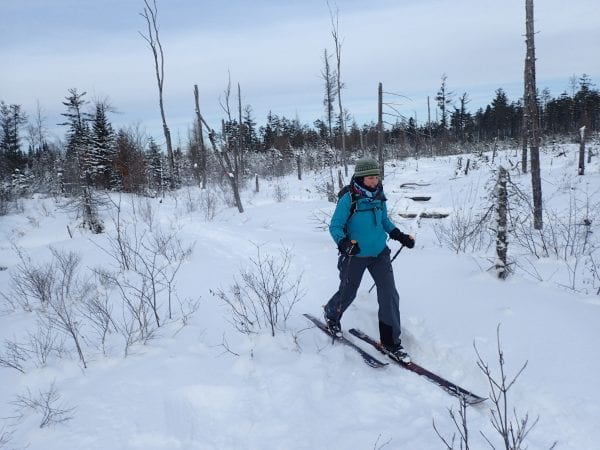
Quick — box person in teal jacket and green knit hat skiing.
[324,158,415,360]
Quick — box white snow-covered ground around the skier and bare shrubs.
[0,146,600,450]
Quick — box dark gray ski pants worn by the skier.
[325,247,400,343]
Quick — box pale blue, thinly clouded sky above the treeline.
[0,0,600,142]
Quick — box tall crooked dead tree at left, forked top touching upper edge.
[139,0,177,189]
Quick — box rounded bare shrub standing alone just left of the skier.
[211,245,303,336]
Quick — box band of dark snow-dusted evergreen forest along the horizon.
[0,74,600,203]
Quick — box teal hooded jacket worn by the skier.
[329,192,396,257]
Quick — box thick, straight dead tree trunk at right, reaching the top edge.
[523,0,544,230]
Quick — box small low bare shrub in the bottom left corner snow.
[12,383,75,428]
